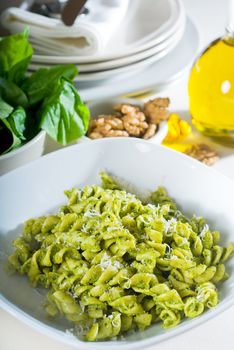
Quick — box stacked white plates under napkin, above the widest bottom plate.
[30,0,186,82]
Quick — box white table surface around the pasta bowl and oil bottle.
[0,0,234,350]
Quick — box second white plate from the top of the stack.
[29,21,185,73]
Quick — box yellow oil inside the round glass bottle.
[188,37,234,140]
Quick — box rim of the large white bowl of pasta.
[0,137,234,350]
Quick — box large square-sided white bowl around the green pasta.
[0,138,234,350]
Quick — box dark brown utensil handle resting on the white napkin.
[62,0,87,26]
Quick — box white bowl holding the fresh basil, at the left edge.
[0,131,46,175]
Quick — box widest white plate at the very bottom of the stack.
[77,19,199,101]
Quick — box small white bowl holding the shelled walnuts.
[86,98,168,144]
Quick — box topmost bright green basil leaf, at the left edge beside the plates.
[0,31,33,84]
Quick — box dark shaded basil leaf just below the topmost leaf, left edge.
[0,77,28,108]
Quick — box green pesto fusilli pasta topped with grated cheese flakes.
[9,173,234,341]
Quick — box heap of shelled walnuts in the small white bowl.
[88,98,170,139]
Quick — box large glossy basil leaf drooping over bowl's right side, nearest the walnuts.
[39,78,90,145]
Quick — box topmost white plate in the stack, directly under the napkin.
[32,0,185,64]
